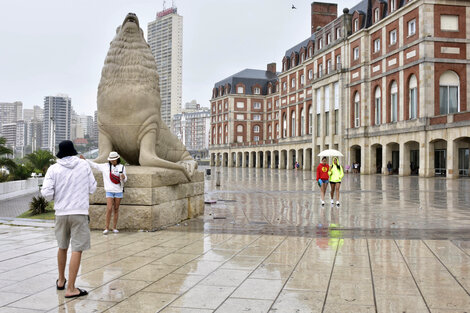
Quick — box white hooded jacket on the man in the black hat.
[41,156,96,215]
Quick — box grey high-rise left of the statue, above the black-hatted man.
[42,95,72,152]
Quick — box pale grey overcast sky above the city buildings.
[0,0,346,115]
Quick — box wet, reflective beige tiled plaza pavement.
[0,168,470,313]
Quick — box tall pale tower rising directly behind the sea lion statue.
[147,7,183,128]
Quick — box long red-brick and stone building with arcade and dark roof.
[210,0,470,178]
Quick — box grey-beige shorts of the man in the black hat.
[55,215,90,251]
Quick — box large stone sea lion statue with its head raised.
[95,13,197,180]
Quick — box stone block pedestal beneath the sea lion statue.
[90,166,204,230]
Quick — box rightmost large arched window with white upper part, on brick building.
[439,71,460,114]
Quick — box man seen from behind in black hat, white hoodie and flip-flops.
[41,140,96,298]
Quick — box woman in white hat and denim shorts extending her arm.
[80,151,127,235]
